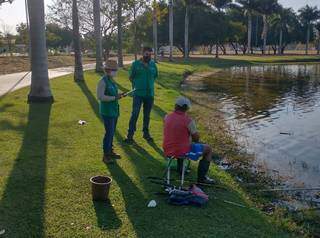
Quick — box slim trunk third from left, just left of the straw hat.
[93,0,103,72]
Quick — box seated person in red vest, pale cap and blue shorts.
[163,97,214,184]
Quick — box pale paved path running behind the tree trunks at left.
[0,61,132,97]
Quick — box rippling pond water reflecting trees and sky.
[202,63,320,187]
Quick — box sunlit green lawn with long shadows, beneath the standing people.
[0,55,318,237]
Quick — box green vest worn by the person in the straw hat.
[100,76,120,117]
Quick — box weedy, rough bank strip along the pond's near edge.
[181,62,320,237]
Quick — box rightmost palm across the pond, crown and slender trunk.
[299,5,320,55]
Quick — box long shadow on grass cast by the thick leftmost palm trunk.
[0,104,51,237]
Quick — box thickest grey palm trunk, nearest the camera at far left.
[28,0,53,103]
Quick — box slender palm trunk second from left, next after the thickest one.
[72,0,84,82]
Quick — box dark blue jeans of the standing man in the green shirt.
[128,96,154,138]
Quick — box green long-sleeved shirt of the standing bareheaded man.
[129,60,158,97]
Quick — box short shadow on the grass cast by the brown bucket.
[93,201,121,230]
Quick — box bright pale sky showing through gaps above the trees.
[0,0,320,33]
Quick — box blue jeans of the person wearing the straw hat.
[102,115,118,154]
